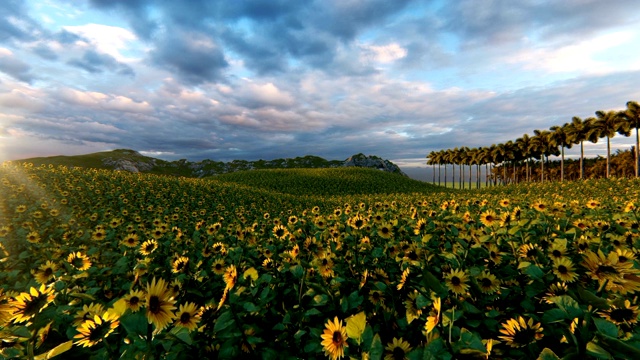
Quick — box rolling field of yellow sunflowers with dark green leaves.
[0,163,640,359]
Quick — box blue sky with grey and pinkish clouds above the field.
[0,0,640,180]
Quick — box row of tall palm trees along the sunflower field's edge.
[427,101,640,188]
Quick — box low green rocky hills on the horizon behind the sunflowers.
[16,149,407,178]
